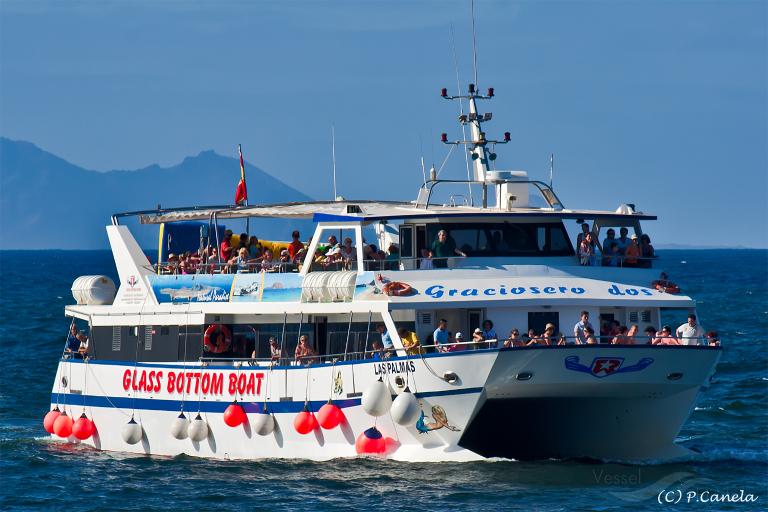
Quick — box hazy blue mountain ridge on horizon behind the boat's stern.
[0,137,310,249]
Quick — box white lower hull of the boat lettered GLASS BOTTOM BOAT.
[51,346,721,461]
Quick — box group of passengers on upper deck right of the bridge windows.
[576,222,656,268]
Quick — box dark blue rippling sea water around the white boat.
[0,250,768,512]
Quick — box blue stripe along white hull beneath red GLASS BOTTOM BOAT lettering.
[51,388,483,413]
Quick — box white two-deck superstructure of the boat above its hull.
[67,181,694,365]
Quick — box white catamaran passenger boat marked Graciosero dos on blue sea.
[45,86,721,461]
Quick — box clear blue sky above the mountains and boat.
[0,0,768,247]
